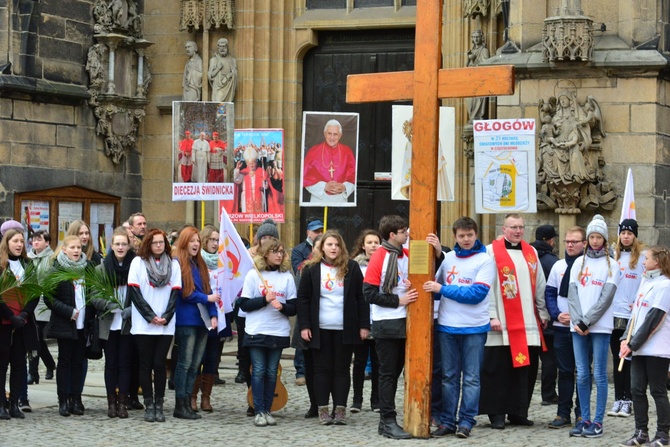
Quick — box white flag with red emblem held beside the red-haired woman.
[216,207,254,332]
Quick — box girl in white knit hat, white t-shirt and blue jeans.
[568,214,619,438]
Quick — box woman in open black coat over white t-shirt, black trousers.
[298,230,370,425]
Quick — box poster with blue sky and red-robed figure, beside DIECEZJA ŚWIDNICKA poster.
[219,129,284,223]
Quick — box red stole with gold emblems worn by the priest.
[491,239,546,368]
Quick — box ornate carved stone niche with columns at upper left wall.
[86,0,152,163]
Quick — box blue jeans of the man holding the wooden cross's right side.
[438,332,486,429]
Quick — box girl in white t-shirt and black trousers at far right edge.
[620,245,670,446]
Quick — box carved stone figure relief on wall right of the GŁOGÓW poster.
[537,91,616,214]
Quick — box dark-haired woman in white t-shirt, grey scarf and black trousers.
[128,229,181,422]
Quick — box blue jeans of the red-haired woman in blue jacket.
[174,325,207,399]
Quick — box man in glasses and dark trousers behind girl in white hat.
[545,227,586,428]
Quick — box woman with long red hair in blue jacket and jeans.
[173,226,220,419]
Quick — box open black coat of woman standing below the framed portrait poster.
[298,260,370,349]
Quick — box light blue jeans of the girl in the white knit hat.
[572,332,610,424]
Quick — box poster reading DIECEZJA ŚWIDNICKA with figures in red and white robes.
[172,101,235,201]
